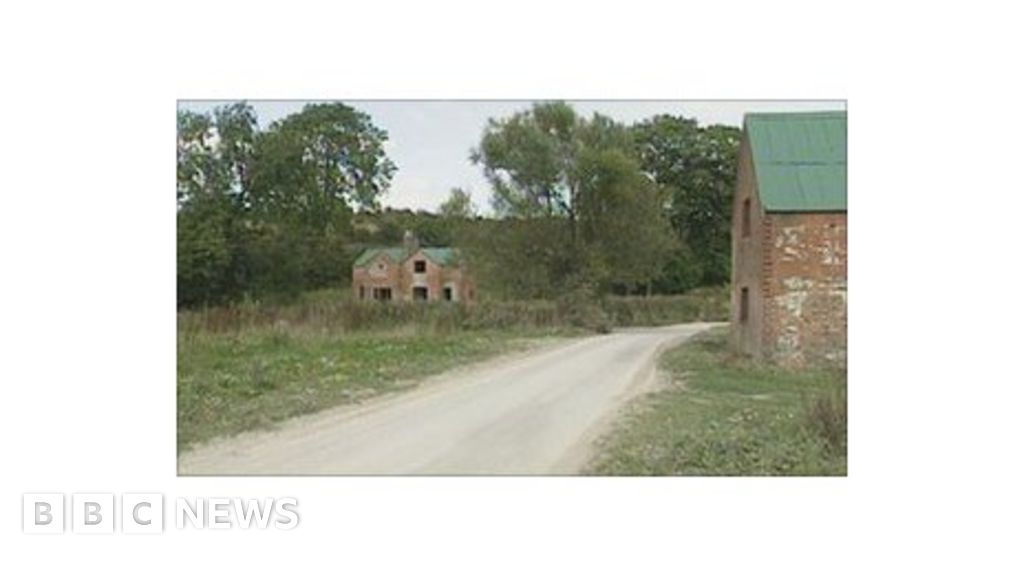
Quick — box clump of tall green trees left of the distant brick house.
[177,102,395,305]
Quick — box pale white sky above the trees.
[178,100,846,213]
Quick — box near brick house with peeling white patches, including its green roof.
[732,112,847,366]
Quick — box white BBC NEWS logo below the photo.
[22,493,299,534]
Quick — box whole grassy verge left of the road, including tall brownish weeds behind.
[177,289,727,451]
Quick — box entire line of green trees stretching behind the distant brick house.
[177,102,739,306]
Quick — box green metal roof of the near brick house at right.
[743,112,846,212]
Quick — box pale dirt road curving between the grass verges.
[178,324,711,475]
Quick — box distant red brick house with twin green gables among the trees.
[352,232,475,301]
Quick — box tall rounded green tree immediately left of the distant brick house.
[251,102,395,294]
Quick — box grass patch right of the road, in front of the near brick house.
[588,329,846,476]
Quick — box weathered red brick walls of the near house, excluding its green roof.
[731,138,847,366]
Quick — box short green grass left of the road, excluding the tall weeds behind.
[177,326,569,452]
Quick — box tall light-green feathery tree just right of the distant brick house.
[470,102,671,293]
